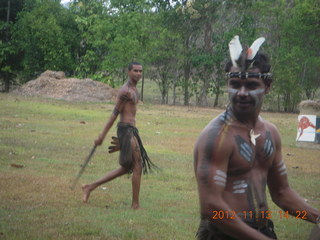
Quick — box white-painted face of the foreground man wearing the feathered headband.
[228,67,269,113]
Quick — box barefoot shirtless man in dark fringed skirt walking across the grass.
[82,62,154,209]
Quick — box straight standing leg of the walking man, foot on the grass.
[131,138,142,210]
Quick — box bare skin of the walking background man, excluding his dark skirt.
[82,65,142,210]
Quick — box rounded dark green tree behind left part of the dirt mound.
[13,0,76,77]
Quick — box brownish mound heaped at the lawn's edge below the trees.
[13,70,117,102]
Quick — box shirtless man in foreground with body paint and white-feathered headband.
[194,36,320,240]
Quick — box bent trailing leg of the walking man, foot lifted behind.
[82,167,127,203]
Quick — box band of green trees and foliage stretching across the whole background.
[0,0,320,111]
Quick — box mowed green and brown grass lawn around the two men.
[0,94,320,240]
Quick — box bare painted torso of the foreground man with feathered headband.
[198,110,276,222]
